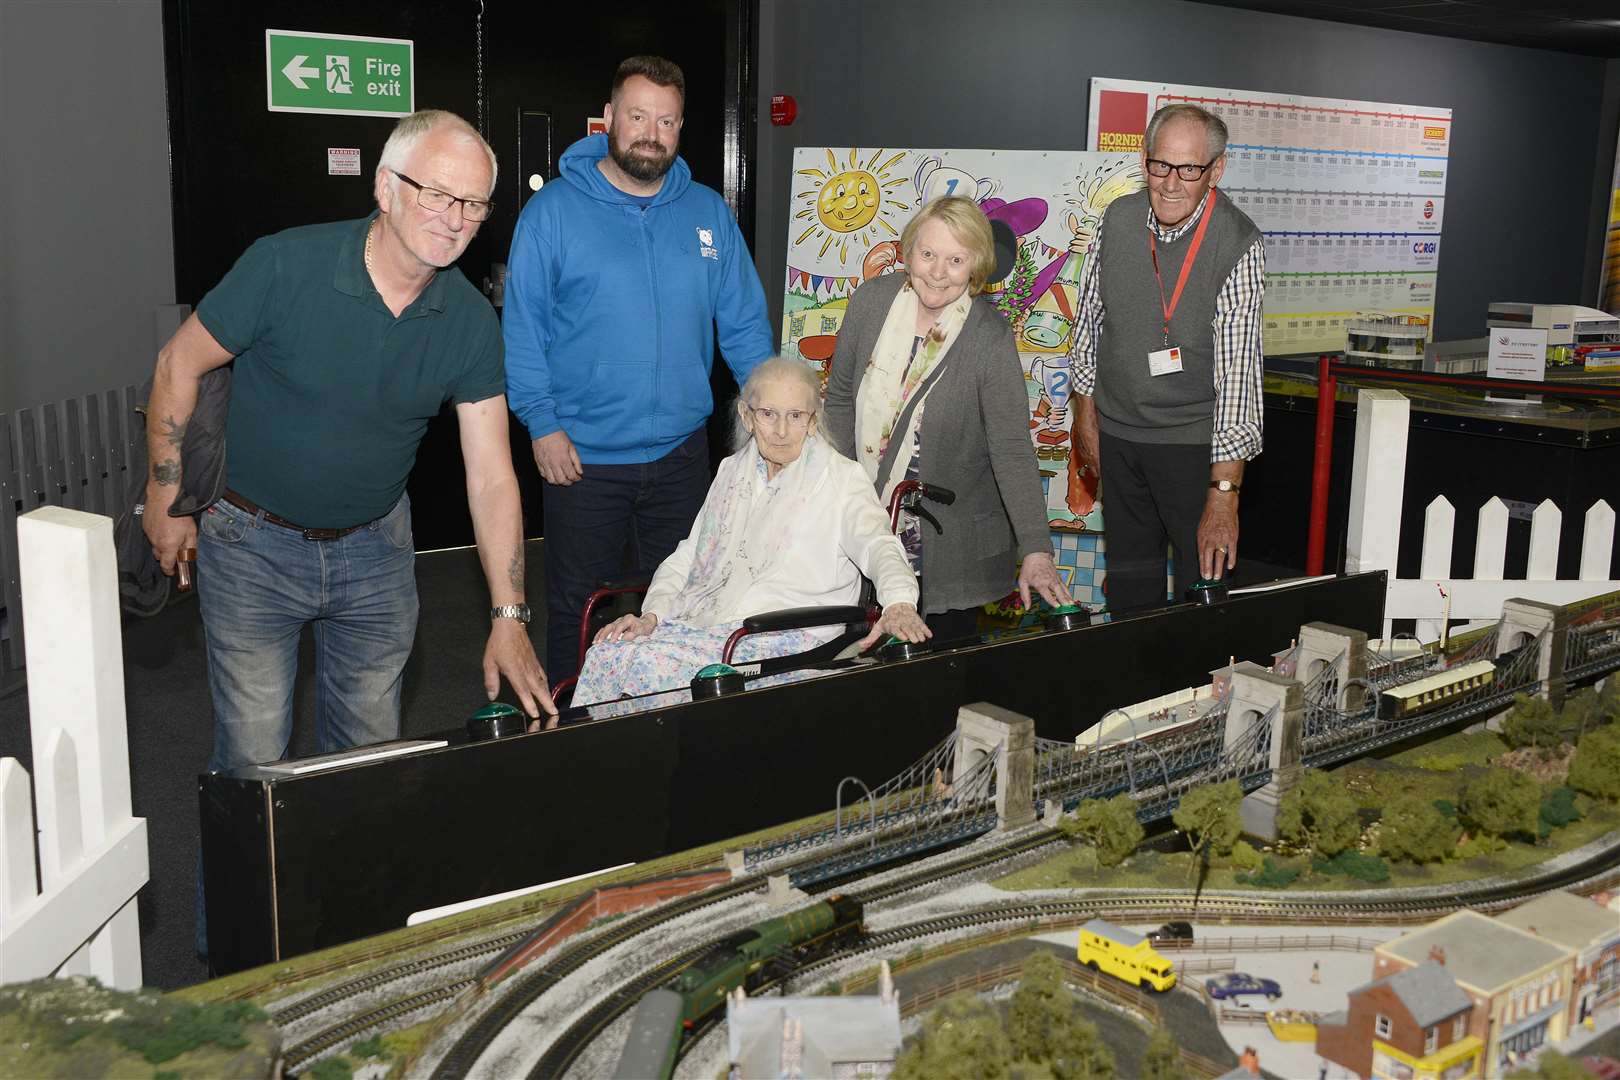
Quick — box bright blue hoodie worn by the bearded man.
[502,134,774,465]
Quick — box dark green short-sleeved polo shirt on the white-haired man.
[198,215,505,528]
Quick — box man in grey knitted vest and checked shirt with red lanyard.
[1069,105,1265,612]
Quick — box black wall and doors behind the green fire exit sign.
[164,0,753,549]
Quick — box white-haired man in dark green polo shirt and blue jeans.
[143,110,556,786]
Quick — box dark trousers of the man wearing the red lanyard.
[1102,432,1210,614]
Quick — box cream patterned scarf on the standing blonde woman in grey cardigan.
[855,282,974,505]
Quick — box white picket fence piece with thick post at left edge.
[0,507,147,989]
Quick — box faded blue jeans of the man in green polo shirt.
[196,497,416,955]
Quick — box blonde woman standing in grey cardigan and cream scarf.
[826,196,1072,640]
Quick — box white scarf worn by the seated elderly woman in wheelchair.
[669,432,836,628]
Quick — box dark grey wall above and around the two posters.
[755,0,1620,338]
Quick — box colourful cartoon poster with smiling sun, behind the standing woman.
[781,147,1142,601]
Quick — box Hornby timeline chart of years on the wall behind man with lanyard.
[1087,79,1452,356]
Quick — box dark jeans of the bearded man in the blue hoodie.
[544,427,710,685]
